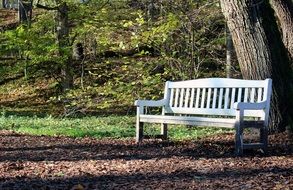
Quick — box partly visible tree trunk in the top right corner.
[270,0,293,60]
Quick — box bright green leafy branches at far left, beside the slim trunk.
[1,9,66,83]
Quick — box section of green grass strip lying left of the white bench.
[0,116,135,138]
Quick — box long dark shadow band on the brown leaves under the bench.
[0,132,293,162]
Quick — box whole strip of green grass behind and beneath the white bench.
[0,116,233,140]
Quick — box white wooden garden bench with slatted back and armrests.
[135,78,272,155]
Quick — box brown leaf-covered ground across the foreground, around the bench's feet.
[0,131,293,189]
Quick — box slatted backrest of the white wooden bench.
[164,78,272,117]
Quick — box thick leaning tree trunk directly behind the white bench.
[221,0,292,132]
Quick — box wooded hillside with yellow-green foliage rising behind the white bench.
[0,1,237,116]
